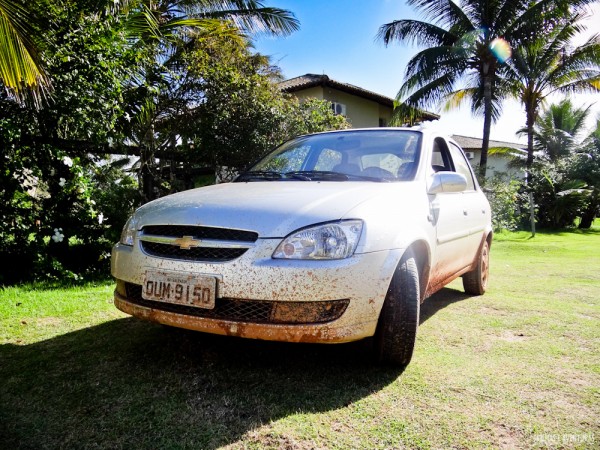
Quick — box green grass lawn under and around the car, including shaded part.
[0,228,600,449]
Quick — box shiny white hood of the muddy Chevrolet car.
[136,181,405,238]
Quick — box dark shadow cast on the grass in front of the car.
[0,318,402,449]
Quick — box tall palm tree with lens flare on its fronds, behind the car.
[378,0,592,177]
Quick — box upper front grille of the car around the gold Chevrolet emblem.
[140,225,258,262]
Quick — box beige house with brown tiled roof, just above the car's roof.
[279,74,440,128]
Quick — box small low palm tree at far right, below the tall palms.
[525,99,591,161]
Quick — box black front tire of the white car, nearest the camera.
[374,251,420,367]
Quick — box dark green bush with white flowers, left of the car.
[0,134,139,284]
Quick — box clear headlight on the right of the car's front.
[273,220,363,259]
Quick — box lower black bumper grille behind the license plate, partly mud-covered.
[125,283,350,324]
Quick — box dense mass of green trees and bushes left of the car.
[0,0,347,284]
